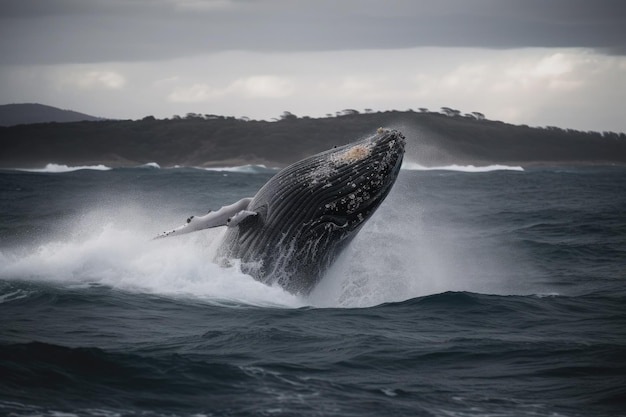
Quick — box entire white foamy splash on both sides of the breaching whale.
[0,177,532,308]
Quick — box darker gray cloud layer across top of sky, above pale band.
[0,0,626,64]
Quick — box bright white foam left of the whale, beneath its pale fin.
[0,210,304,308]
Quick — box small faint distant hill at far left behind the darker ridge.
[0,103,102,126]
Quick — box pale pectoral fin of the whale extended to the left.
[155,198,256,239]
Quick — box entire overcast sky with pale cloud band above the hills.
[0,0,626,132]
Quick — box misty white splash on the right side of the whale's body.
[308,174,534,308]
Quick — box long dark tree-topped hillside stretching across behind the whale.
[0,111,626,168]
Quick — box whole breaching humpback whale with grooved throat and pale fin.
[157,128,406,295]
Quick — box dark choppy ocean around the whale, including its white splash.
[0,163,626,417]
